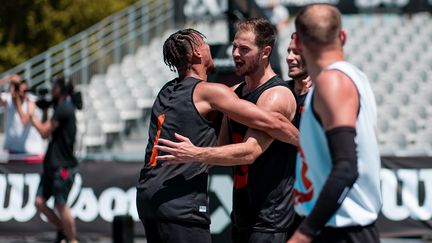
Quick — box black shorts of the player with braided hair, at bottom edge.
[141,219,211,243]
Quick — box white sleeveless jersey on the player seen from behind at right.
[294,62,382,227]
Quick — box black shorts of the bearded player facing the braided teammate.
[232,227,290,243]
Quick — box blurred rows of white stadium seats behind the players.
[80,13,432,154]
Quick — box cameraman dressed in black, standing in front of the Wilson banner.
[30,77,81,243]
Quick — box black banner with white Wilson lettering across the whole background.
[0,157,432,239]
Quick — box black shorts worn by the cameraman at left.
[37,167,78,204]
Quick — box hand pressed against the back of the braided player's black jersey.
[155,133,199,165]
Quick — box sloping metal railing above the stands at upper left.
[0,0,174,85]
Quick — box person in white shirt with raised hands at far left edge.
[0,74,45,163]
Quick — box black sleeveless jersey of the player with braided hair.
[137,77,217,224]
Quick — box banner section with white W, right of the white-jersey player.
[378,157,432,237]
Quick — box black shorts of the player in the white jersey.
[312,224,380,243]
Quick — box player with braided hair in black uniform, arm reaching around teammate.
[137,29,298,243]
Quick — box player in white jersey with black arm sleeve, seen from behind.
[288,4,381,243]
